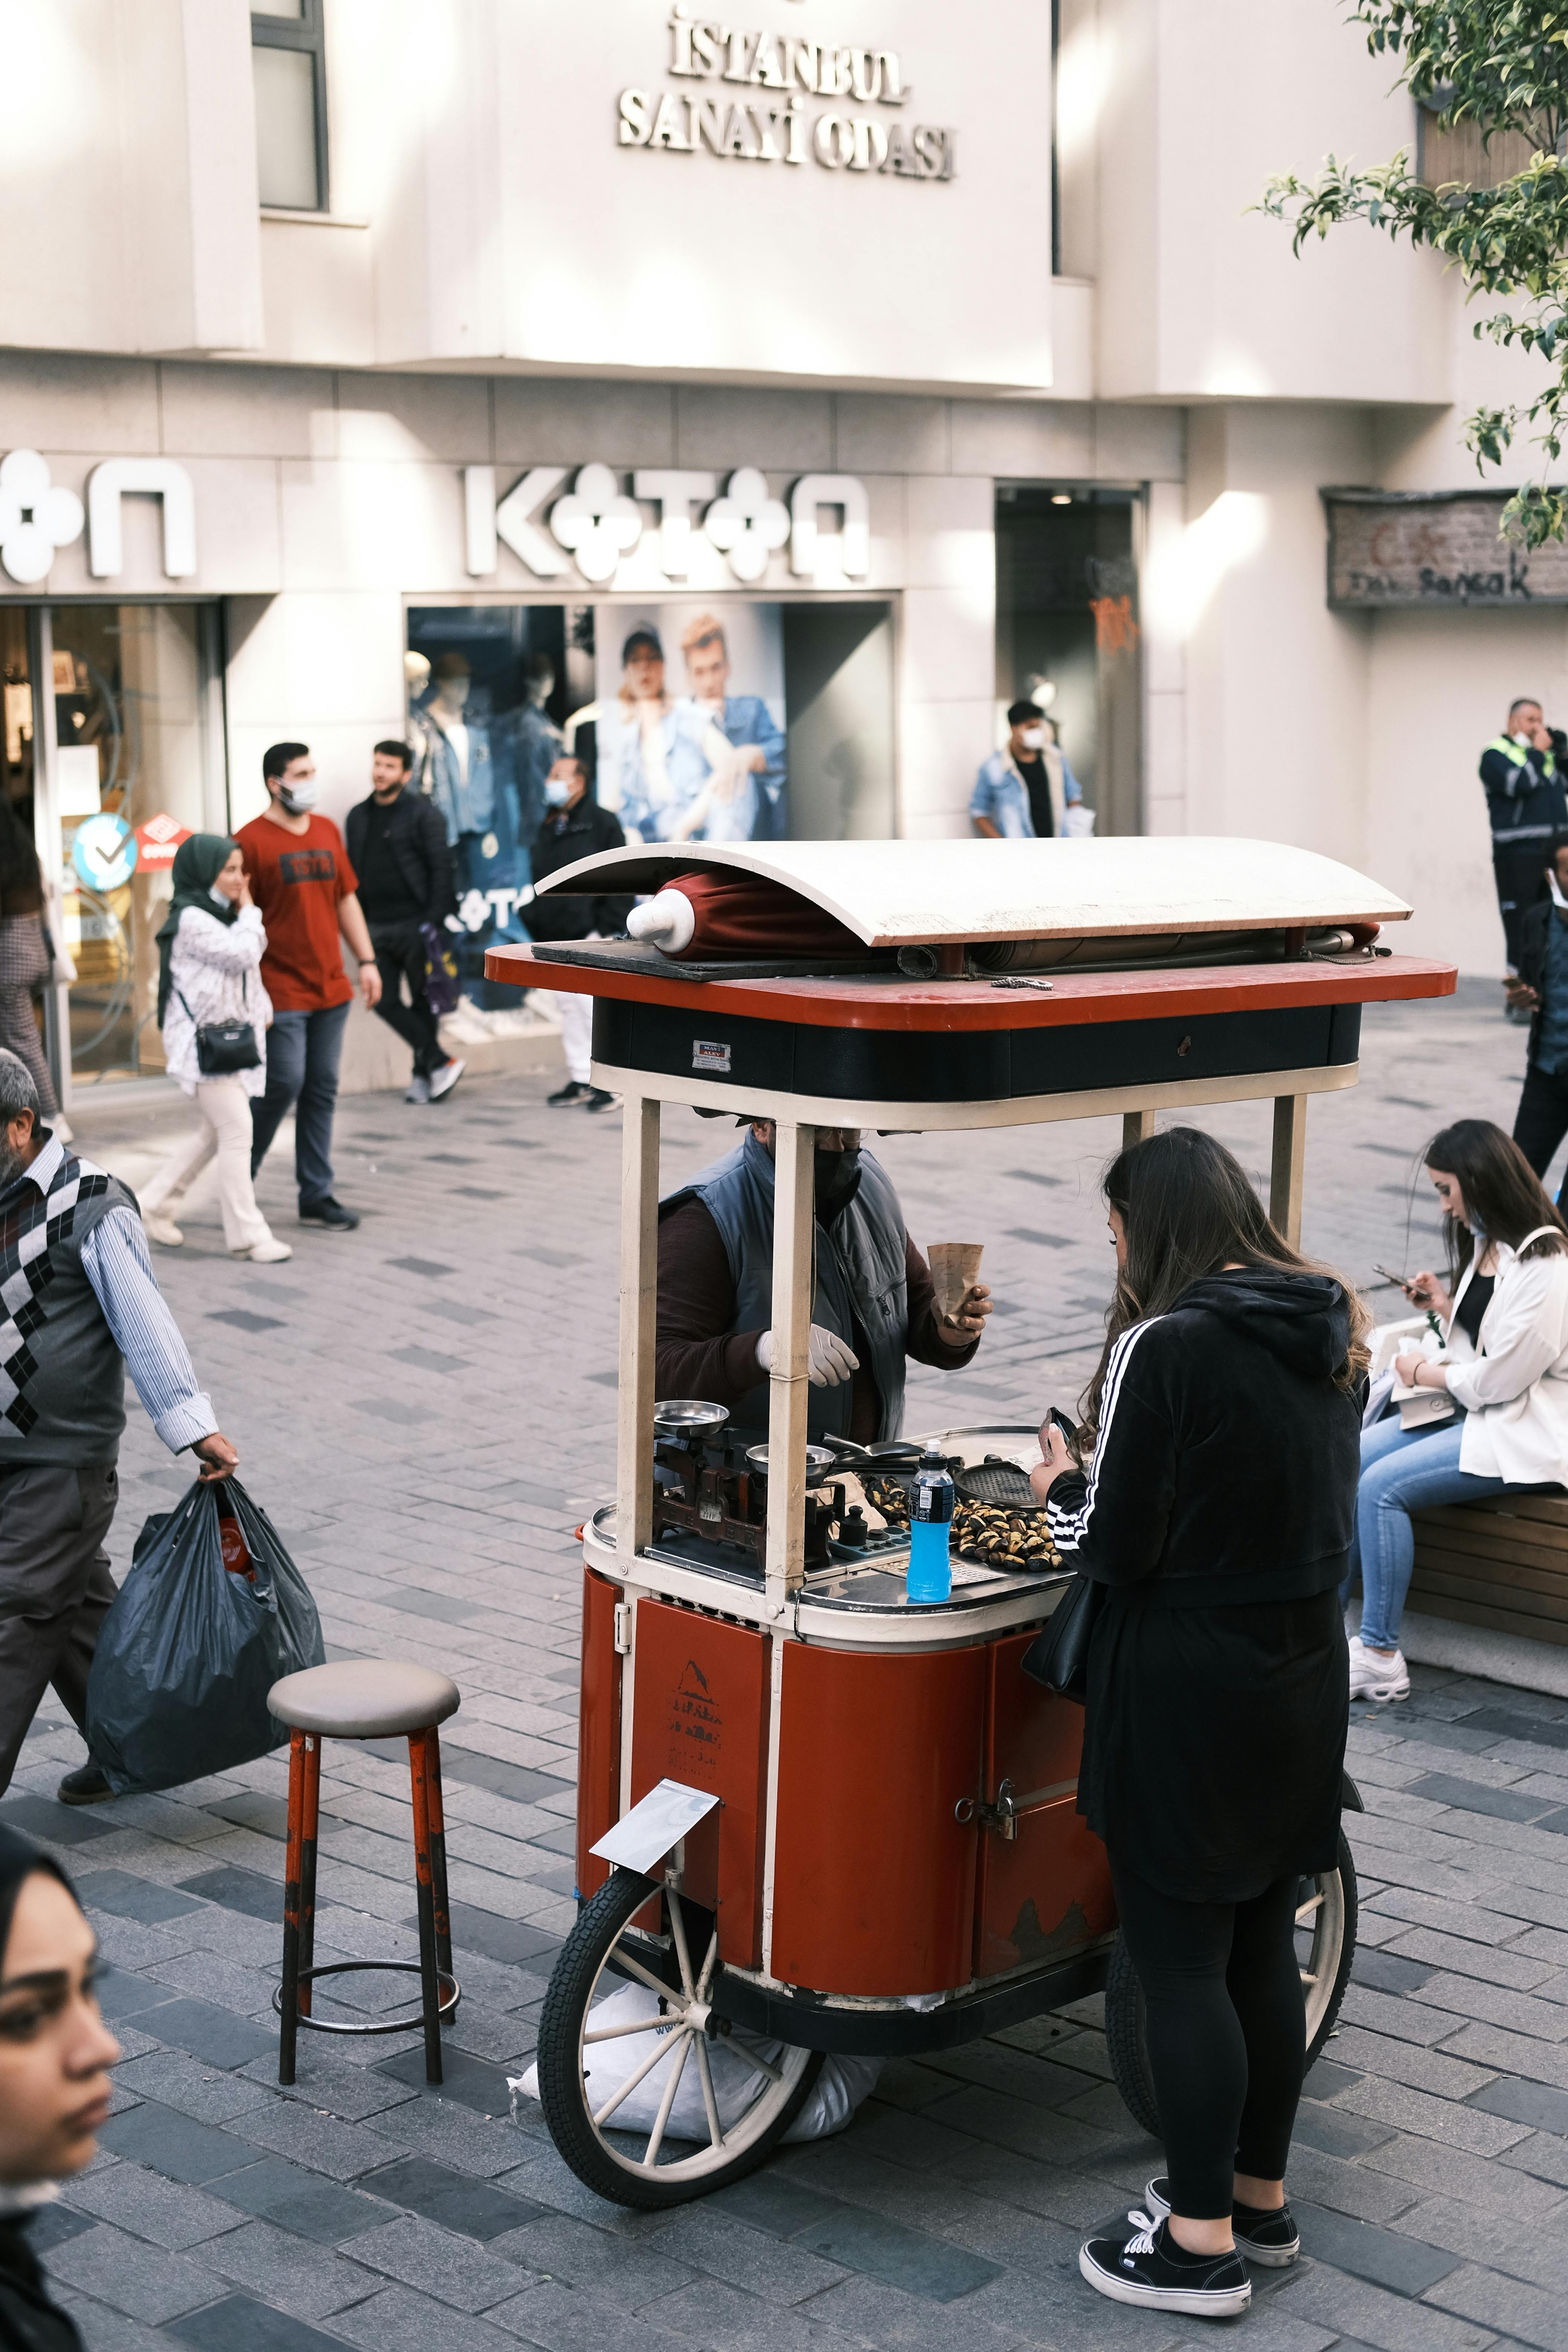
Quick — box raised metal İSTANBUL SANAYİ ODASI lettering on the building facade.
[616,7,954,179]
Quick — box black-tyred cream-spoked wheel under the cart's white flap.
[538,1870,823,2206]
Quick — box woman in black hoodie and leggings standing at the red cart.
[1034,1127,1368,2314]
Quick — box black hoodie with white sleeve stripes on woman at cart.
[1049,1268,1361,1609]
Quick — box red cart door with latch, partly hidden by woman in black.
[975,1632,1117,1976]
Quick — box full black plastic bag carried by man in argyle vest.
[87,1477,325,1797]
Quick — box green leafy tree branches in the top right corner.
[1260,0,1568,548]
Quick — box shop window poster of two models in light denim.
[595,602,787,842]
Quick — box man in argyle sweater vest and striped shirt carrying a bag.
[0,1049,240,1804]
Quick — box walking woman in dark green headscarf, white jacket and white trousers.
[141,833,294,1265]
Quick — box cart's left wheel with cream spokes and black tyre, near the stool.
[538,1870,823,2208]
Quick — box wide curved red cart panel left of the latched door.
[771,1642,985,1995]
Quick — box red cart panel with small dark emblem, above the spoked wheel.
[632,1599,769,1969]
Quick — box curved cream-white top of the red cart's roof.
[541,835,1410,948]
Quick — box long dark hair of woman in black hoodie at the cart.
[1081,1127,1373,1435]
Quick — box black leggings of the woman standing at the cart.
[1110,1856,1307,2220]
